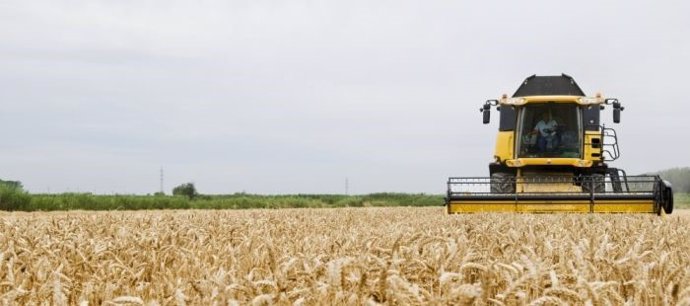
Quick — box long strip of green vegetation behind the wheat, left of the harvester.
[0,191,443,211]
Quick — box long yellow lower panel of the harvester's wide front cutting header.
[447,200,655,214]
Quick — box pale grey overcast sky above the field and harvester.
[0,0,690,194]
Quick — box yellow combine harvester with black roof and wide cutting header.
[446,74,673,215]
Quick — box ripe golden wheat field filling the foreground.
[0,207,690,305]
